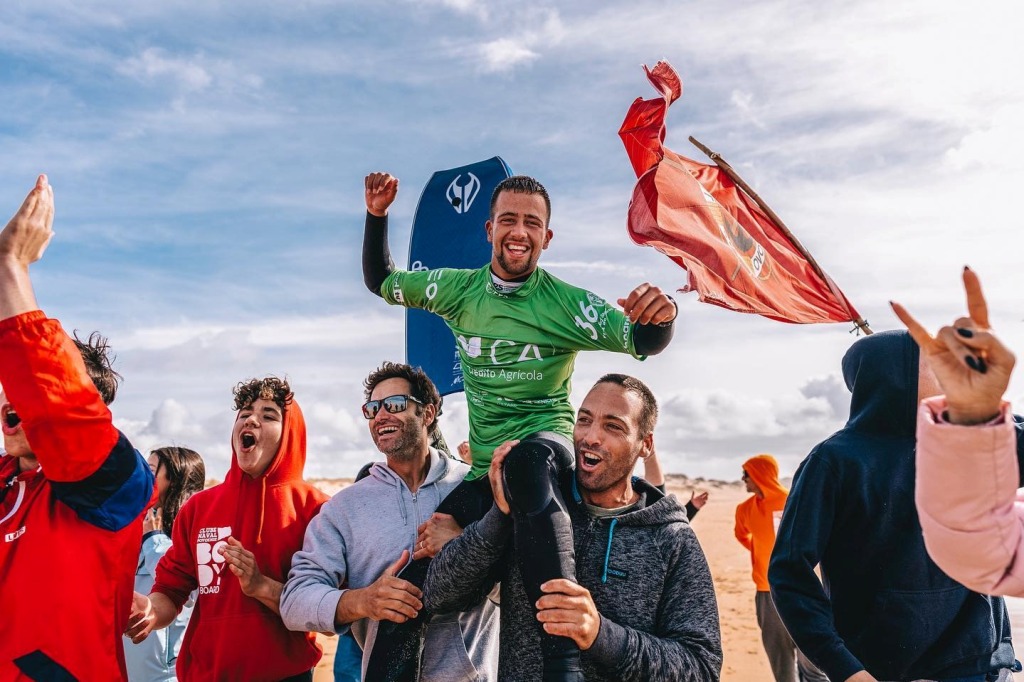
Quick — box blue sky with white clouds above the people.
[0,0,1024,479]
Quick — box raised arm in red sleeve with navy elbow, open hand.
[0,175,153,520]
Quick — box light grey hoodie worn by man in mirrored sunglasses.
[281,447,498,682]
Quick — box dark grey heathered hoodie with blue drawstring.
[424,481,722,682]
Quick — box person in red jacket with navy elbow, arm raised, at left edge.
[0,175,153,682]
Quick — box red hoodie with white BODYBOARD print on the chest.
[153,400,328,682]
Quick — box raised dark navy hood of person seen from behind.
[843,331,920,437]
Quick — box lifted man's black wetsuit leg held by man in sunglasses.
[364,476,495,682]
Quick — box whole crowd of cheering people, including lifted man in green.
[0,173,1024,682]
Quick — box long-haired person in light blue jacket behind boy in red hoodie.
[125,446,206,682]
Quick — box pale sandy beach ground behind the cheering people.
[303,475,1024,682]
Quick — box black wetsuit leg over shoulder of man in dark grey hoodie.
[502,431,584,682]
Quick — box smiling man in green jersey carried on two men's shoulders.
[362,173,676,681]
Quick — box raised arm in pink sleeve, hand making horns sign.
[892,267,1024,596]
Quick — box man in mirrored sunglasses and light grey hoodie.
[281,363,498,682]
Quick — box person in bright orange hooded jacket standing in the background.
[735,455,828,682]
